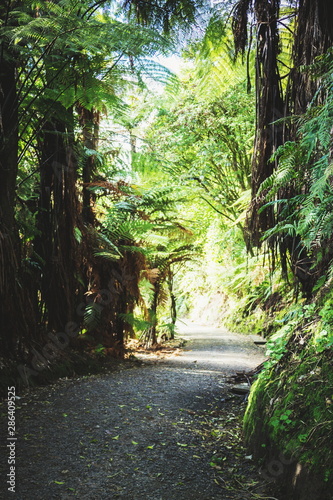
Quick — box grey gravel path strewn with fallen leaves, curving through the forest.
[0,324,274,500]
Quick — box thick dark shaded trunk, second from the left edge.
[36,109,79,331]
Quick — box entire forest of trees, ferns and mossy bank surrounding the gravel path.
[0,0,333,498]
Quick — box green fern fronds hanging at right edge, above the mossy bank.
[259,50,333,292]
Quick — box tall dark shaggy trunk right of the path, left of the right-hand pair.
[248,0,284,246]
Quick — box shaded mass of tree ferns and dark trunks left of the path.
[0,0,194,384]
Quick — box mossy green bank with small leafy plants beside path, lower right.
[244,290,333,488]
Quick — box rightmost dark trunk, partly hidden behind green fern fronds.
[279,0,333,297]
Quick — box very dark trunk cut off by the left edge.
[0,42,36,359]
